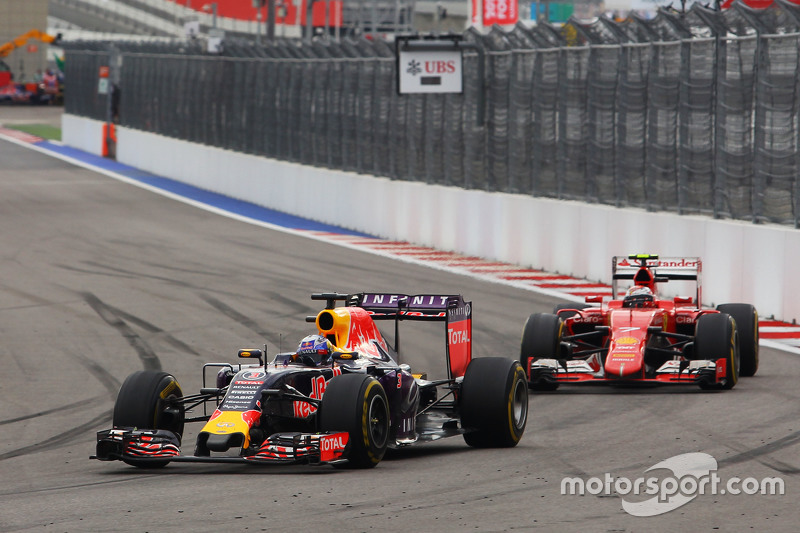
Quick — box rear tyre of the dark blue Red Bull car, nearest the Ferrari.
[460,357,528,448]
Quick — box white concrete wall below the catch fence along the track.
[63,115,800,322]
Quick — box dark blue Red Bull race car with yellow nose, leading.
[93,293,528,468]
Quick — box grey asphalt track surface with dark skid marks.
[0,115,800,532]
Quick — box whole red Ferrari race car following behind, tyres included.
[520,254,758,390]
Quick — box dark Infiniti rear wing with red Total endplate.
[311,292,472,379]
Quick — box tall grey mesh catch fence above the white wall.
[66,0,800,227]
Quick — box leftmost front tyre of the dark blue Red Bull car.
[113,370,184,468]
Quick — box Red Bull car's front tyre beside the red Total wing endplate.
[319,374,390,468]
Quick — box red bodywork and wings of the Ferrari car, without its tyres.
[527,256,726,384]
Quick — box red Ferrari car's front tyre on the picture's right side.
[694,313,740,390]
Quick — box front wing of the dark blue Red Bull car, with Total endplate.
[91,428,349,465]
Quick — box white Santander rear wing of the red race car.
[611,254,703,307]
